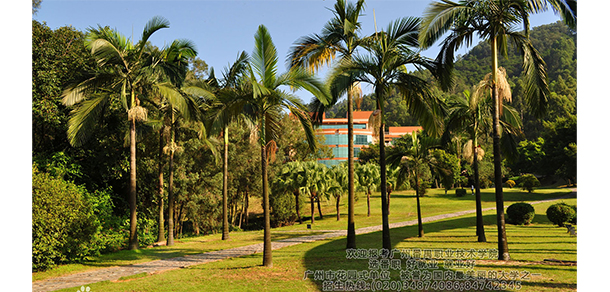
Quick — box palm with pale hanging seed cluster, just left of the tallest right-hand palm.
[442,67,522,242]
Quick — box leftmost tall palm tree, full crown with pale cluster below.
[62,16,196,249]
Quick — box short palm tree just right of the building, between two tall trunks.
[387,132,438,237]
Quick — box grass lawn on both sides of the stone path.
[33,189,576,291]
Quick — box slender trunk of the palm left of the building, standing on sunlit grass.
[259,125,273,267]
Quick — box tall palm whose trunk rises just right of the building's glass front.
[329,17,442,249]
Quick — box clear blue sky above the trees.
[32,0,559,102]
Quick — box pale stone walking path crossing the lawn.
[32,189,576,292]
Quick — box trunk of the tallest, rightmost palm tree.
[491,37,510,261]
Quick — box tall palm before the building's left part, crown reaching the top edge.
[289,0,364,249]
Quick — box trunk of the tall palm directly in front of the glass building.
[346,90,356,249]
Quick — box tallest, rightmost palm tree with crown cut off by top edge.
[420,0,576,260]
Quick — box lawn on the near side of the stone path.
[53,193,576,291]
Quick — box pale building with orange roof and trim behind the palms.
[316,111,422,166]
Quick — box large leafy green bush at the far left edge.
[32,166,101,271]
